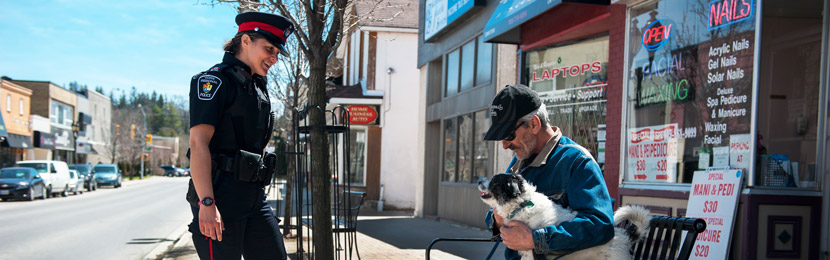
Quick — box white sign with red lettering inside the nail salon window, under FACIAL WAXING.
[628,124,679,182]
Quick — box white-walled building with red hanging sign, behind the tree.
[326,0,423,209]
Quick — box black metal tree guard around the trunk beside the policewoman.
[287,106,365,259]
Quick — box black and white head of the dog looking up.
[478,174,525,208]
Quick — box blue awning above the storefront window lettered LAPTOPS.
[484,0,610,44]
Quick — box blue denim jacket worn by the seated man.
[485,132,614,259]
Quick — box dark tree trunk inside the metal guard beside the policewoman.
[308,51,334,259]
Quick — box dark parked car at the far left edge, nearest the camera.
[0,167,49,201]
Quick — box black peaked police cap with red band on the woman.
[236,12,294,55]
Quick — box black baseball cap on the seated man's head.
[484,84,542,141]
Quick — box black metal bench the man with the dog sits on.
[426,216,706,260]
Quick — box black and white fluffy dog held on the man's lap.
[478,174,651,259]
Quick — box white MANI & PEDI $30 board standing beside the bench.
[684,170,743,259]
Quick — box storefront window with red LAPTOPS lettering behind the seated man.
[525,36,608,163]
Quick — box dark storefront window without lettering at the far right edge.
[754,0,827,189]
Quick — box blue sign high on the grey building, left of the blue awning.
[424,0,484,42]
